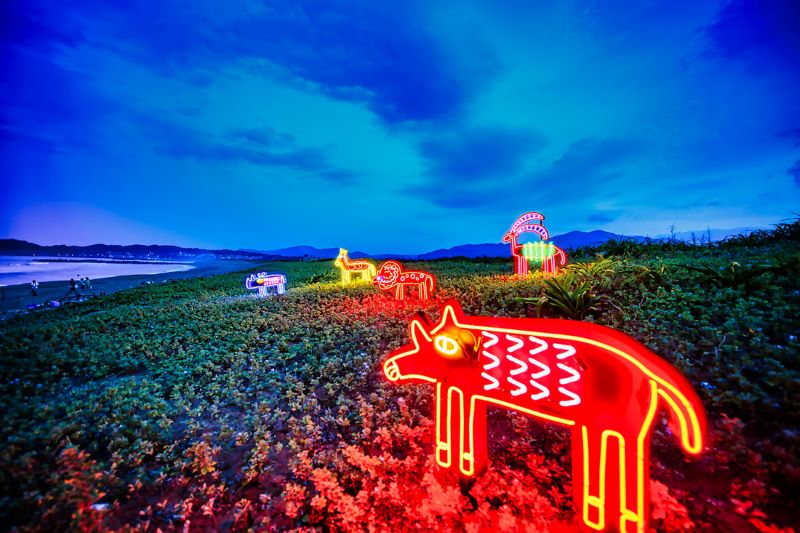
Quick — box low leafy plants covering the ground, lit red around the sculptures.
[0,222,800,532]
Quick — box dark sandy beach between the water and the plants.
[0,260,263,320]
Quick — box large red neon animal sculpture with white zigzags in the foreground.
[383,301,705,533]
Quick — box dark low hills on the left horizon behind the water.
[0,239,286,261]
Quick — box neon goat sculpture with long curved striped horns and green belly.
[503,211,567,277]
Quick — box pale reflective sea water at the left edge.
[0,256,194,287]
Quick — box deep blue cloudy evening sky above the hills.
[0,0,800,253]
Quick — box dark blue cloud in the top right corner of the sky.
[704,0,800,78]
